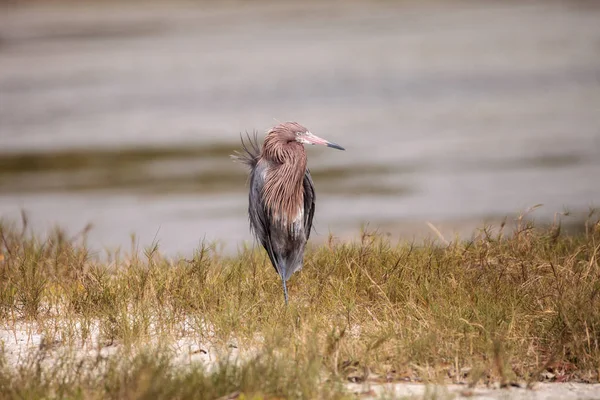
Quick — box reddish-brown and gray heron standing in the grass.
[234,122,344,304]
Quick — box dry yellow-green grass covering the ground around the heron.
[0,211,600,399]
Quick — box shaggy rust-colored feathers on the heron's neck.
[261,134,306,226]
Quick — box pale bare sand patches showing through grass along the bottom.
[0,323,600,400]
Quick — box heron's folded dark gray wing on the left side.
[248,163,281,275]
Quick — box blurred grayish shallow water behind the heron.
[0,1,600,253]
